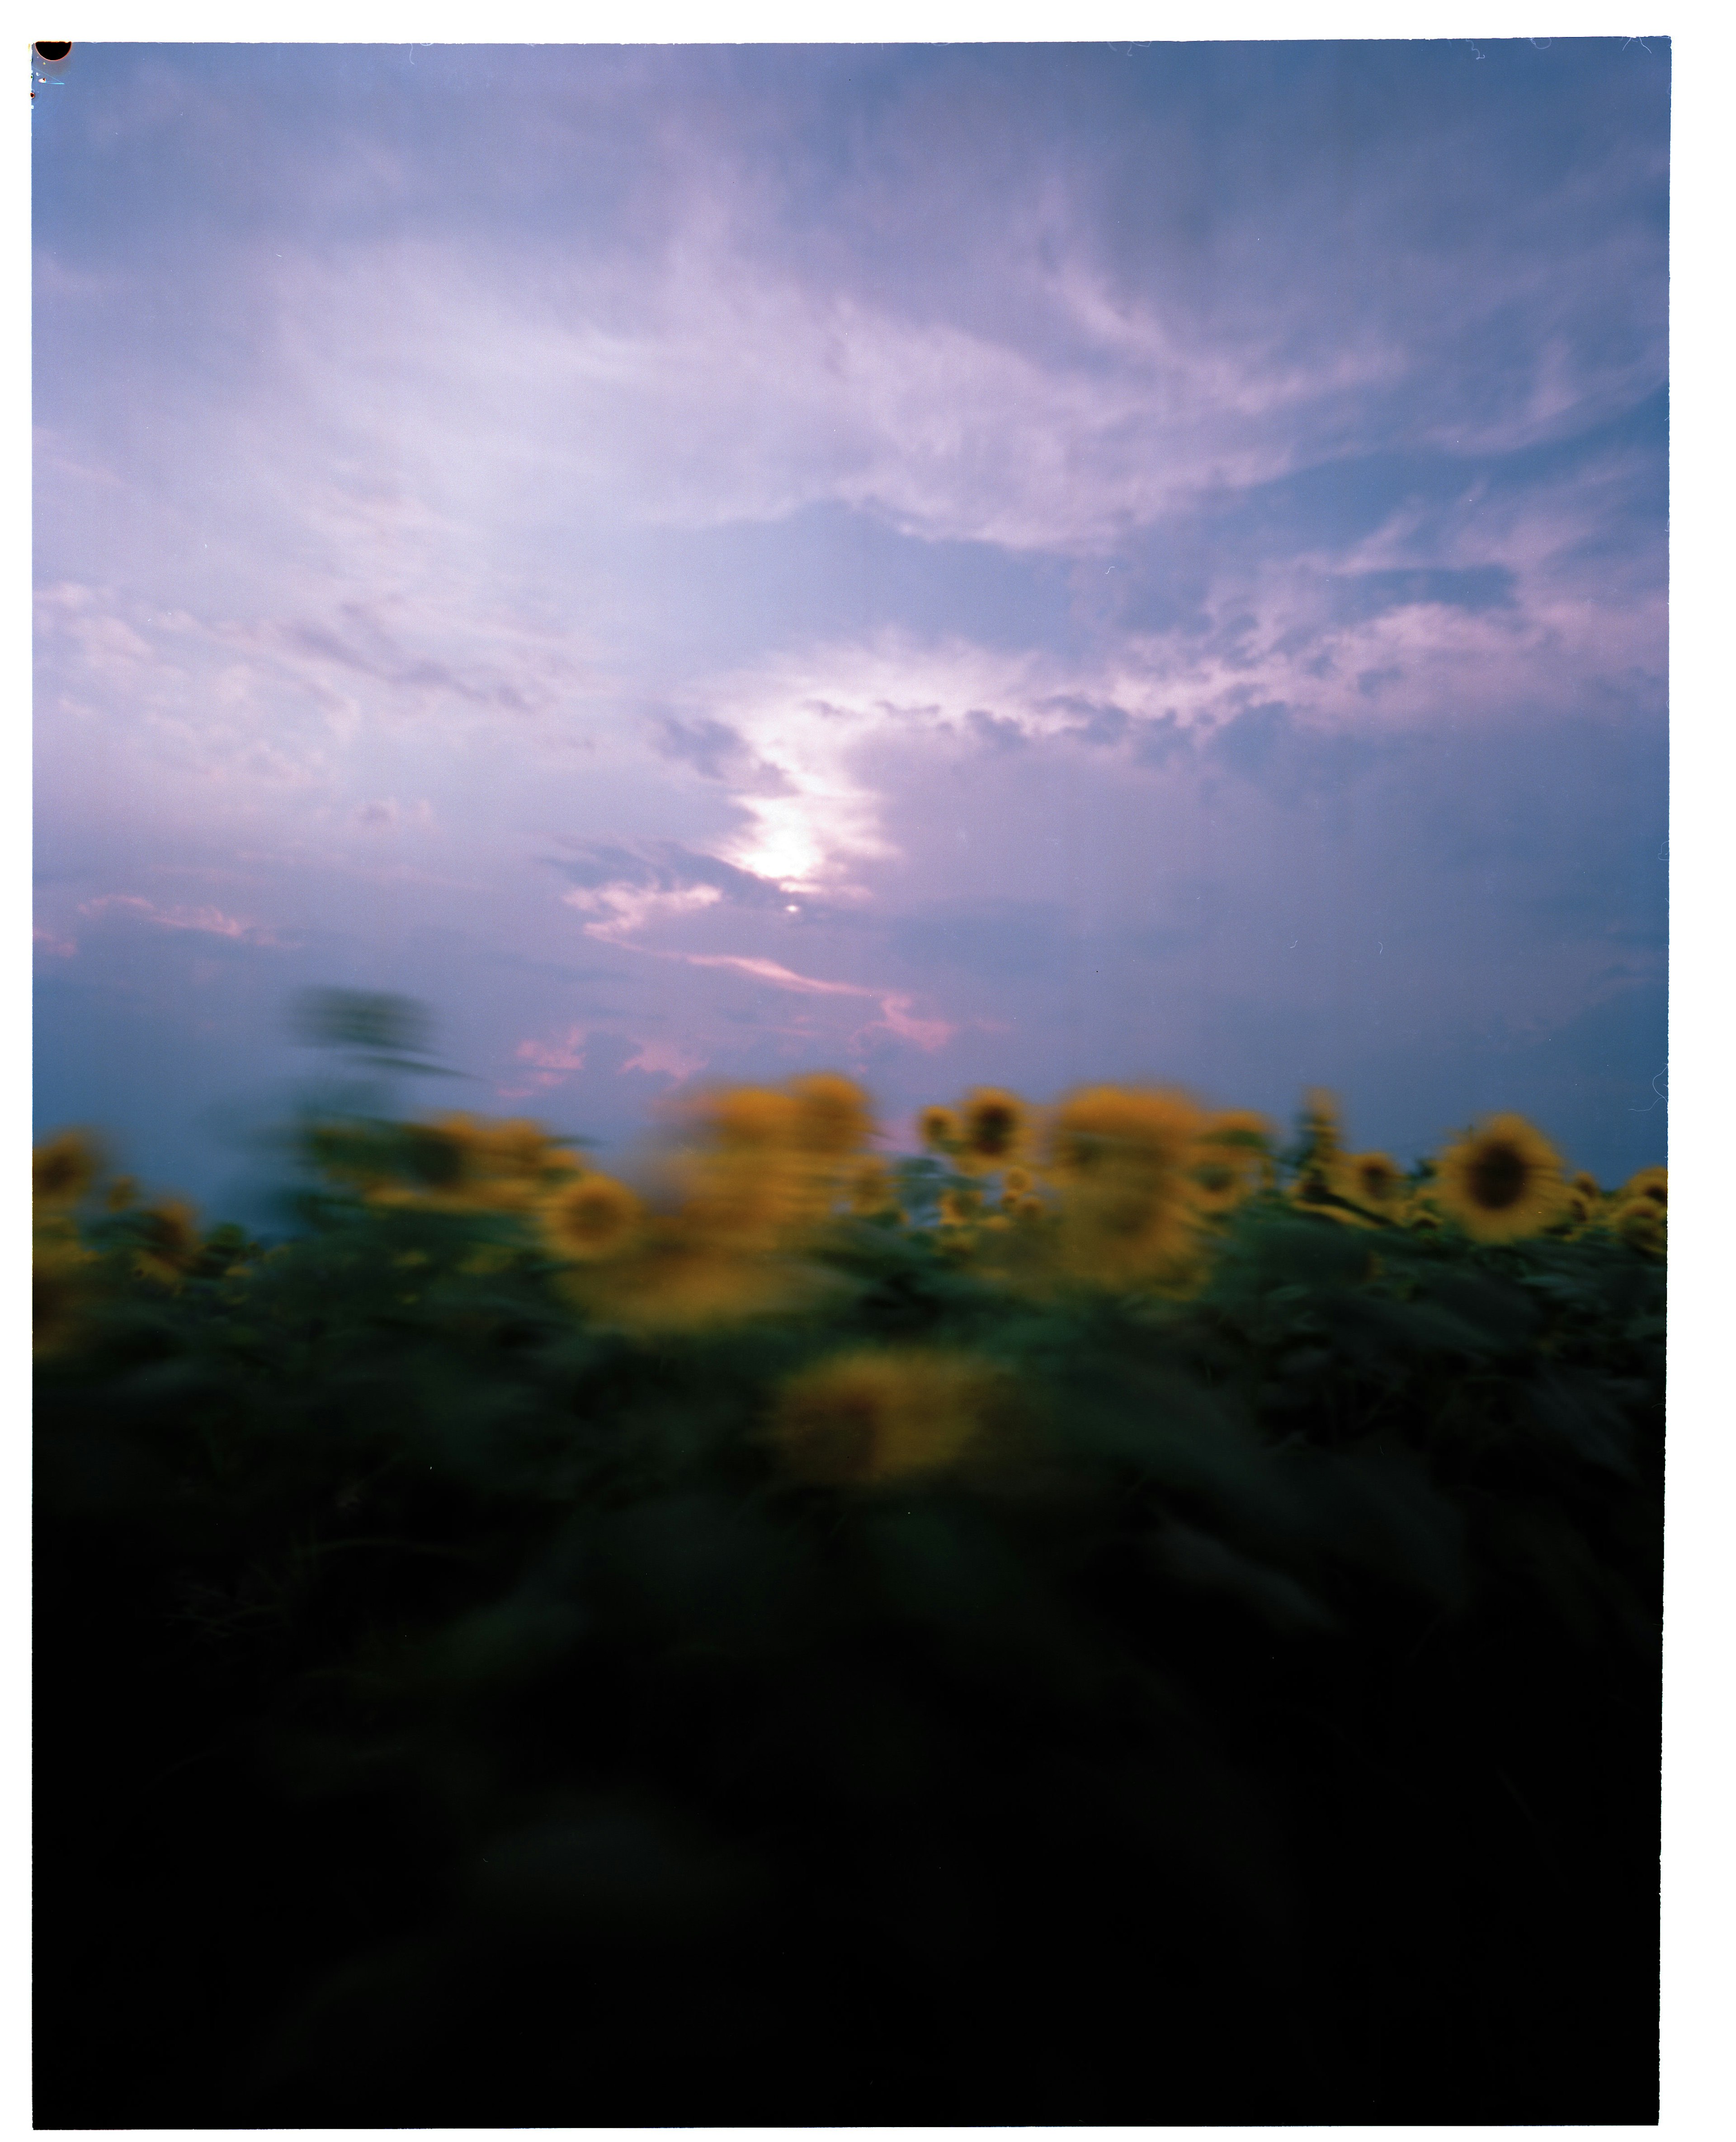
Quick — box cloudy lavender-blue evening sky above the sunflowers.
[32,37,1670,1204]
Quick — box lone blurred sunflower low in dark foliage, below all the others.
[771,1348,1004,1486]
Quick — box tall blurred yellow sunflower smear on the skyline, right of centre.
[1047,1086,1205,1285]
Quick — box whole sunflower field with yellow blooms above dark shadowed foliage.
[34,1045,1667,2127]
